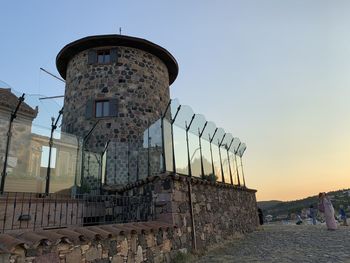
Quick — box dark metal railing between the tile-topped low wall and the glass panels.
[0,192,155,233]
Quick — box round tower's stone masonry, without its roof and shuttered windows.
[62,47,170,152]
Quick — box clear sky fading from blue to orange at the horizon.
[0,0,350,200]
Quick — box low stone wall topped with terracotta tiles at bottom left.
[0,222,186,263]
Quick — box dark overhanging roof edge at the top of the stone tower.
[56,35,179,85]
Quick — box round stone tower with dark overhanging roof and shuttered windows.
[56,35,178,188]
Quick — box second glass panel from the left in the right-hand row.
[173,125,188,175]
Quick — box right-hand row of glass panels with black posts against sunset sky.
[162,99,246,186]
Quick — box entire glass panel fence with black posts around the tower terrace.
[0,94,246,194]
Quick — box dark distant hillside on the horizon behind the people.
[258,189,350,220]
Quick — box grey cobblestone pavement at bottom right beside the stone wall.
[196,225,350,263]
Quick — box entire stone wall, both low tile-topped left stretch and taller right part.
[0,174,258,263]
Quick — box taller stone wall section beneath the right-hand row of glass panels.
[123,174,258,249]
